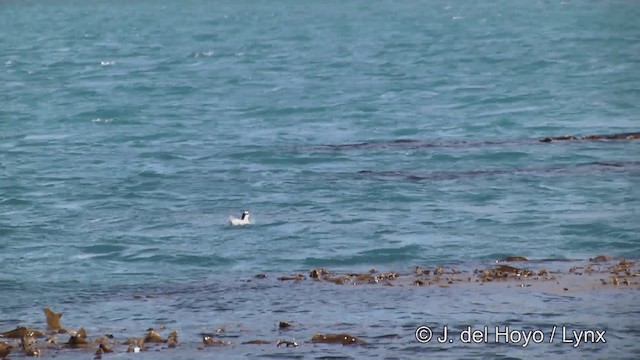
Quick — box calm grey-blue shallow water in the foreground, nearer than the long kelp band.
[0,261,640,359]
